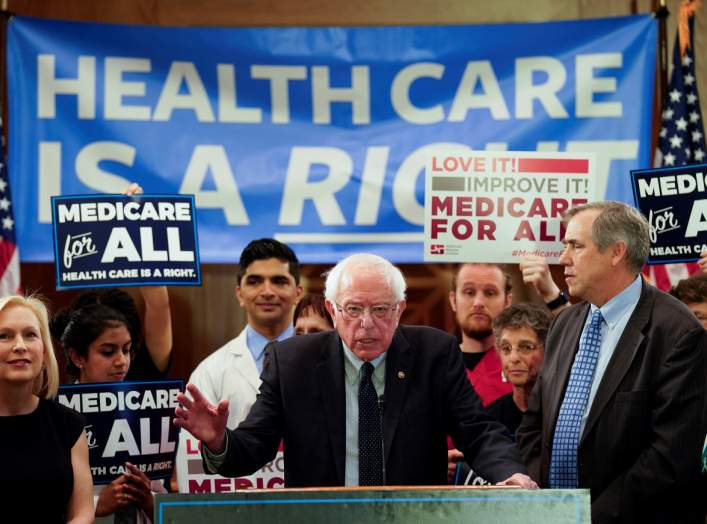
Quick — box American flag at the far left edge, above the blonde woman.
[0,120,21,297]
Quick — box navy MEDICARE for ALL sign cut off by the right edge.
[631,164,707,264]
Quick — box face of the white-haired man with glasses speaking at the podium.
[326,268,405,361]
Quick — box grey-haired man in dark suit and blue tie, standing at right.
[517,202,707,523]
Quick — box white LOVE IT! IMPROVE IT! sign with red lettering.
[425,149,596,263]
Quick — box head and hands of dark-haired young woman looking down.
[52,298,164,523]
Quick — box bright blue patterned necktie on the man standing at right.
[550,309,603,488]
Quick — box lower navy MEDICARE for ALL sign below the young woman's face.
[57,380,184,484]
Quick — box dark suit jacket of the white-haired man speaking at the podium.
[218,326,525,487]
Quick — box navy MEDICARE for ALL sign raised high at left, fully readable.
[52,195,201,289]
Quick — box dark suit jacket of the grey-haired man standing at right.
[517,283,707,524]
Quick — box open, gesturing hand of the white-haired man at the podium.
[174,384,228,453]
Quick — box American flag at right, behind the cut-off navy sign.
[647,13,707,291]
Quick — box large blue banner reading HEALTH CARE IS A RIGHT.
[8,16,656,263]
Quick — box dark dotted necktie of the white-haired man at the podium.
[358,362,383,486]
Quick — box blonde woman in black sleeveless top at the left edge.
[0,296,93,523]
